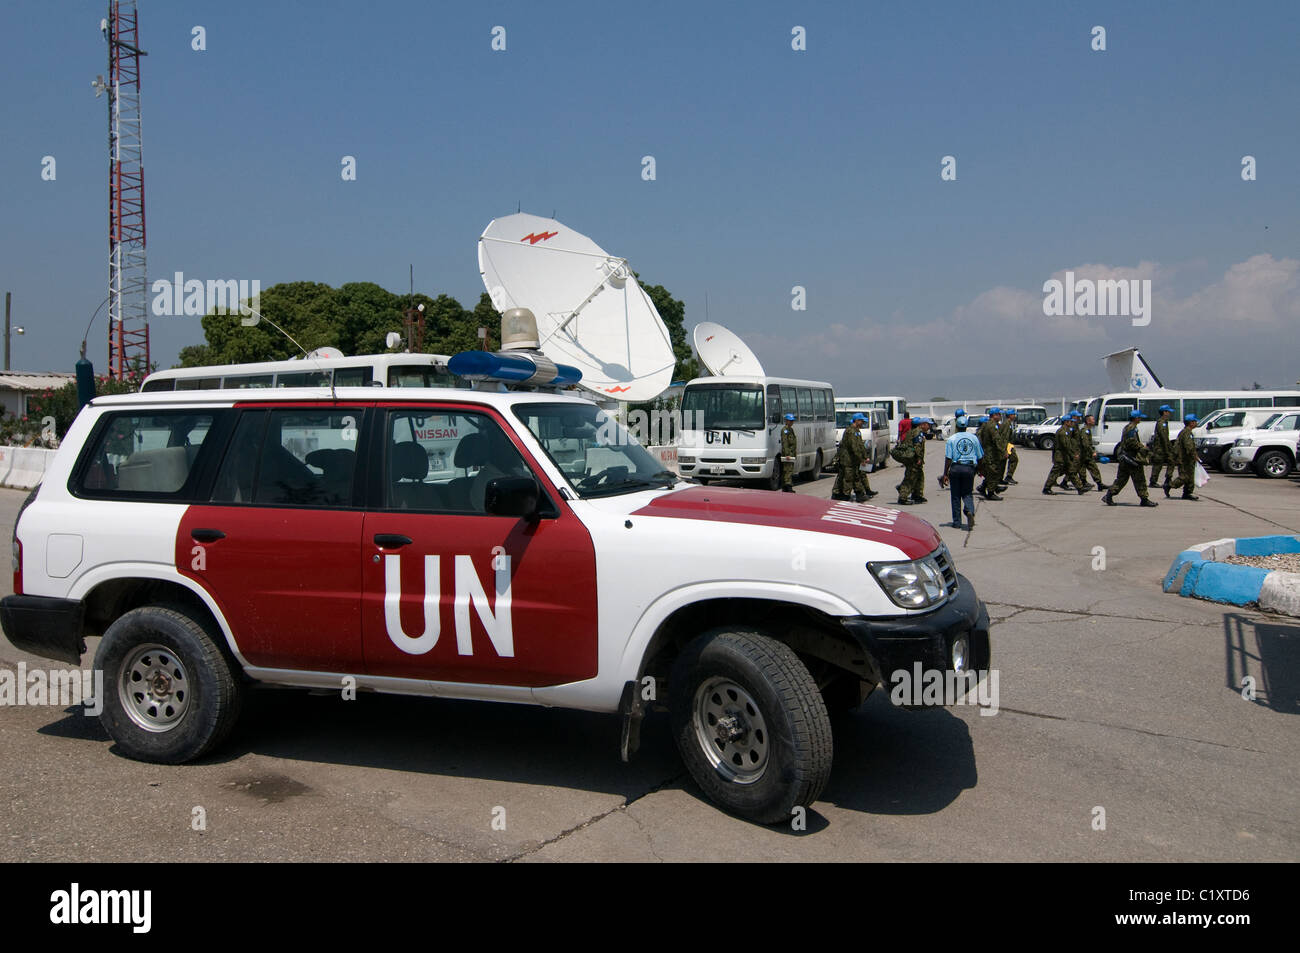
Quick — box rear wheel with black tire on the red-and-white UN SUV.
[95,606,242,764]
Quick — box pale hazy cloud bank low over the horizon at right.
[745,254,1300,399]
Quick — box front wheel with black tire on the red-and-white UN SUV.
[670,629,833,824]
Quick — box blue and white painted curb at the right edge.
[1162,536,1300,615]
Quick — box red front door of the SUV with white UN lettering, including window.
[361,407,597,685]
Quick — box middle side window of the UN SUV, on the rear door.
[212,408,364,507]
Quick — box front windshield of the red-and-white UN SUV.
[514,403,677,498]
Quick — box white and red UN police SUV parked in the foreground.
[0,387,989,823]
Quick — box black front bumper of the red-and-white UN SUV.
[842,573,992,705]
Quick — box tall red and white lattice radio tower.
[98,0,150,380]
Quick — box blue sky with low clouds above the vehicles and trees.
[0,0,1300,399]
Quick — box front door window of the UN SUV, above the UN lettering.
[384,407,532,514]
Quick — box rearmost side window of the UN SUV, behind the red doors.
[70,410,220,501]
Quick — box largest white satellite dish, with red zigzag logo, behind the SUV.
[478,213,677,403]
